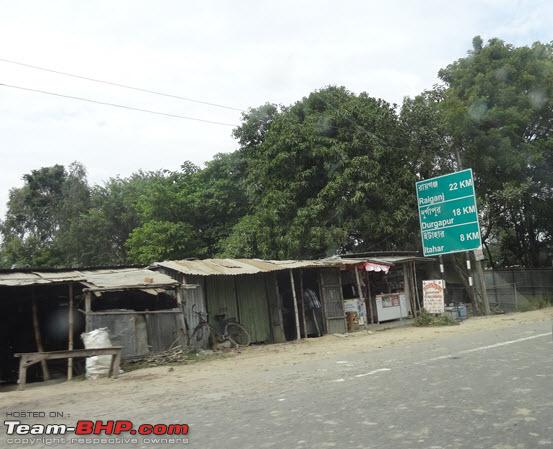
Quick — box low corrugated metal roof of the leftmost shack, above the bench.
[0,268,178,289]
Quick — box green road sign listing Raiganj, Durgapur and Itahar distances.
[416,168,482,256]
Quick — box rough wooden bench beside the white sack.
[14,346,121,390]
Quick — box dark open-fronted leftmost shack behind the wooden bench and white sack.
[0,267,180,383]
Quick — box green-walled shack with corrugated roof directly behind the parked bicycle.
[150,258,357,345]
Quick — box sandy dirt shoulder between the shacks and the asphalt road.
[0,308,553,409]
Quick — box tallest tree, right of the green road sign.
[439,37,553,267]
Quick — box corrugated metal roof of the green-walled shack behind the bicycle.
[152,257,382,276]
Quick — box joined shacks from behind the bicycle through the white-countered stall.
[150,255,432,347]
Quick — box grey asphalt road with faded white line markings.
[5,321,553,449]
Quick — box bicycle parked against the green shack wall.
[192,304,251,347]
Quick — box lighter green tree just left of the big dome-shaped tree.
[126,152,248,263]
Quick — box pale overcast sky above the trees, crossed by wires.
[0,0,553,215]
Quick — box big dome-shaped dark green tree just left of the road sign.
[220,87,418,258]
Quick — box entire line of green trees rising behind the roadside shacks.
[0,37,553,267]
